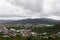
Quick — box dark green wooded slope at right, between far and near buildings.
[32,24,60,33]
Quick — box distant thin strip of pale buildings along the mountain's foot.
[0,23,53,27]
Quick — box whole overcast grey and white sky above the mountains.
[0,0,60,20]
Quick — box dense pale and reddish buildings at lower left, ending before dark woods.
[0,27,37,37]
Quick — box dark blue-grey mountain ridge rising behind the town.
[4,18,60,24]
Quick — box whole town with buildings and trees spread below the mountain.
[0,24,60,40]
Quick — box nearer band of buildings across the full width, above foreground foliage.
[0,27,60,38]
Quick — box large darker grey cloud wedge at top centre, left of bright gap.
[7,0,43,12]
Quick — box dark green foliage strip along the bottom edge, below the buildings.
[0,35,60,40]
